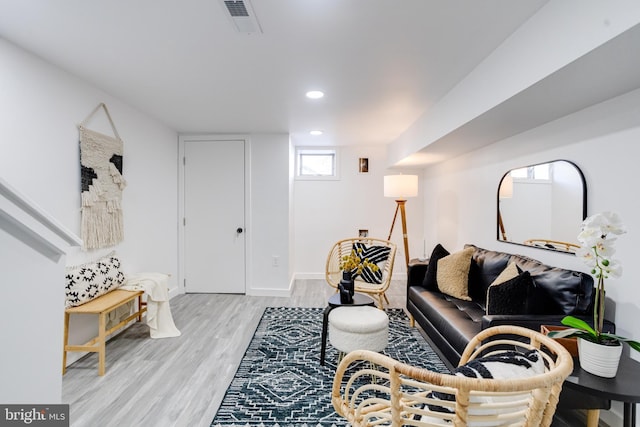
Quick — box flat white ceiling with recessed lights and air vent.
[0,0,547,145]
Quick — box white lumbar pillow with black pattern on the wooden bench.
[65,252,125,308]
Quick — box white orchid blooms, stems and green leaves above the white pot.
[549,212,640,351]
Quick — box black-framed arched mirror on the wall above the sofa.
[497,160,587,253]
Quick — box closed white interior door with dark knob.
[183,140,245,294]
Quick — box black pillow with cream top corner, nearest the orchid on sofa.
[486,262,533,315]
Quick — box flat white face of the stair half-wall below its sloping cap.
[0,221,69,404]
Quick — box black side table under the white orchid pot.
[563,354,640,427]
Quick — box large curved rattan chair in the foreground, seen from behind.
[331,326,573,427]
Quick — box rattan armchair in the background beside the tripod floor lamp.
[325,237,397,309]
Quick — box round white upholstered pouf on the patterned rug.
[329,306,389,353]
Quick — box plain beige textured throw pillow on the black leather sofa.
[437,248,475,301]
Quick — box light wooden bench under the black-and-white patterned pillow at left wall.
[62,289,147,376]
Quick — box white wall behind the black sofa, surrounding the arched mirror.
[422,90,640,425]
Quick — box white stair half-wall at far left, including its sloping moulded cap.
[0,179,82,403]
